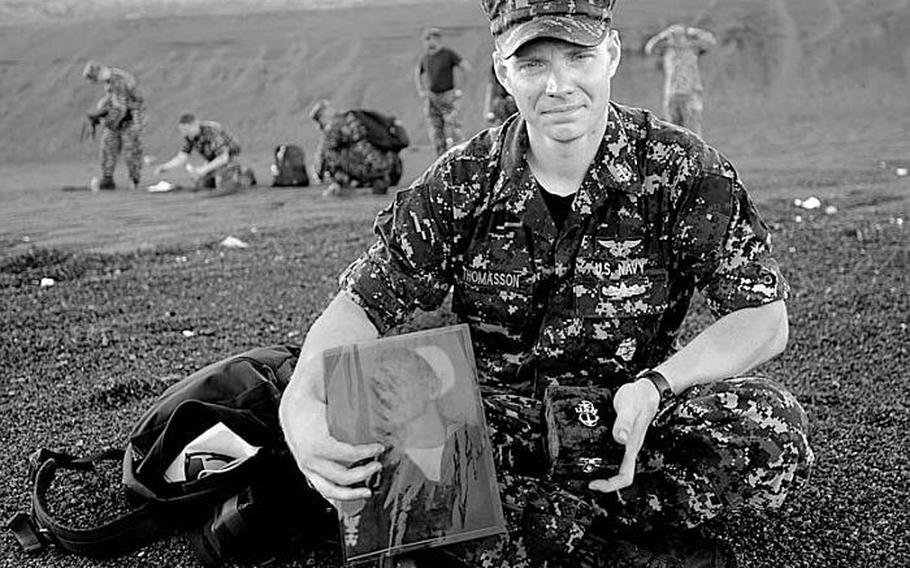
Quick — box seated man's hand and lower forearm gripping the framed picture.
[280,364,384,507]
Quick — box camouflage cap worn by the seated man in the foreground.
[481,0,616,57]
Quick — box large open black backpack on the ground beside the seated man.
[7,345,337,566]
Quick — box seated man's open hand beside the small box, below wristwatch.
[588,379,660,493]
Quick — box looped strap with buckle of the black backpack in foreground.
[6,448,170,557]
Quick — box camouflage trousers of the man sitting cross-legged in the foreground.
[438,377,814,568]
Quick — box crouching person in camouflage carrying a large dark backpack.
[310,99,401,196]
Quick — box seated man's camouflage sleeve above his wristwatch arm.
[673,169,789,317]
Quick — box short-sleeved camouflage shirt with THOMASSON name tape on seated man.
[341,104,788,394]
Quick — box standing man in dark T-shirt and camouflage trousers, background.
[414,28,471,155]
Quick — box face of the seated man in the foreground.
[493,30,620,142]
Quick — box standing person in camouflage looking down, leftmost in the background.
[82,61,146,189]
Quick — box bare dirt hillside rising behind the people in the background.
[0,0,910,173]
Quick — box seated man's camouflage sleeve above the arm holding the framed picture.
[340,163,453,333]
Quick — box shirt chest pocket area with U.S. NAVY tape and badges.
[572,236,669,318]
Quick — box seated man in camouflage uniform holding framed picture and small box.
[280,0,814,568]
